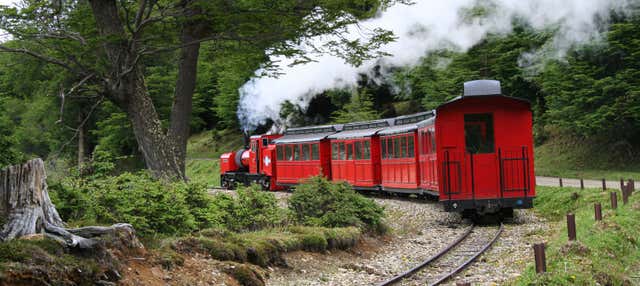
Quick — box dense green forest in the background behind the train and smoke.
[0,1,640,174]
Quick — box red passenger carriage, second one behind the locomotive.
[328,119,389,190]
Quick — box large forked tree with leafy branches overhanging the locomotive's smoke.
[0,0,395,179]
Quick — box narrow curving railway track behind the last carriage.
[378,224,504,286]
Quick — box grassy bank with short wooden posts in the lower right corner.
[514,187,640,285]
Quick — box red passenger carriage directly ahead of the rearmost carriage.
[378,111,433,194]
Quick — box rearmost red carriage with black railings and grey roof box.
[436,80,535,213]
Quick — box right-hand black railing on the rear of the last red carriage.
[498,146,530,197]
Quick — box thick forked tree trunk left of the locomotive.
[90,0,200,180]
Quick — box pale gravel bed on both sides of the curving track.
[267,199,547,285]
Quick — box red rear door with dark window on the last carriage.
[464,113,500,199]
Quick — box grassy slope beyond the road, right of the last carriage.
[535,135,640,181]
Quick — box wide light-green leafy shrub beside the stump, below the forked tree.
[51,172,215,236]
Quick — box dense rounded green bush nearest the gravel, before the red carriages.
[289,177,384,231]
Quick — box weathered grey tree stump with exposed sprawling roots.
[0,158,142,249]
